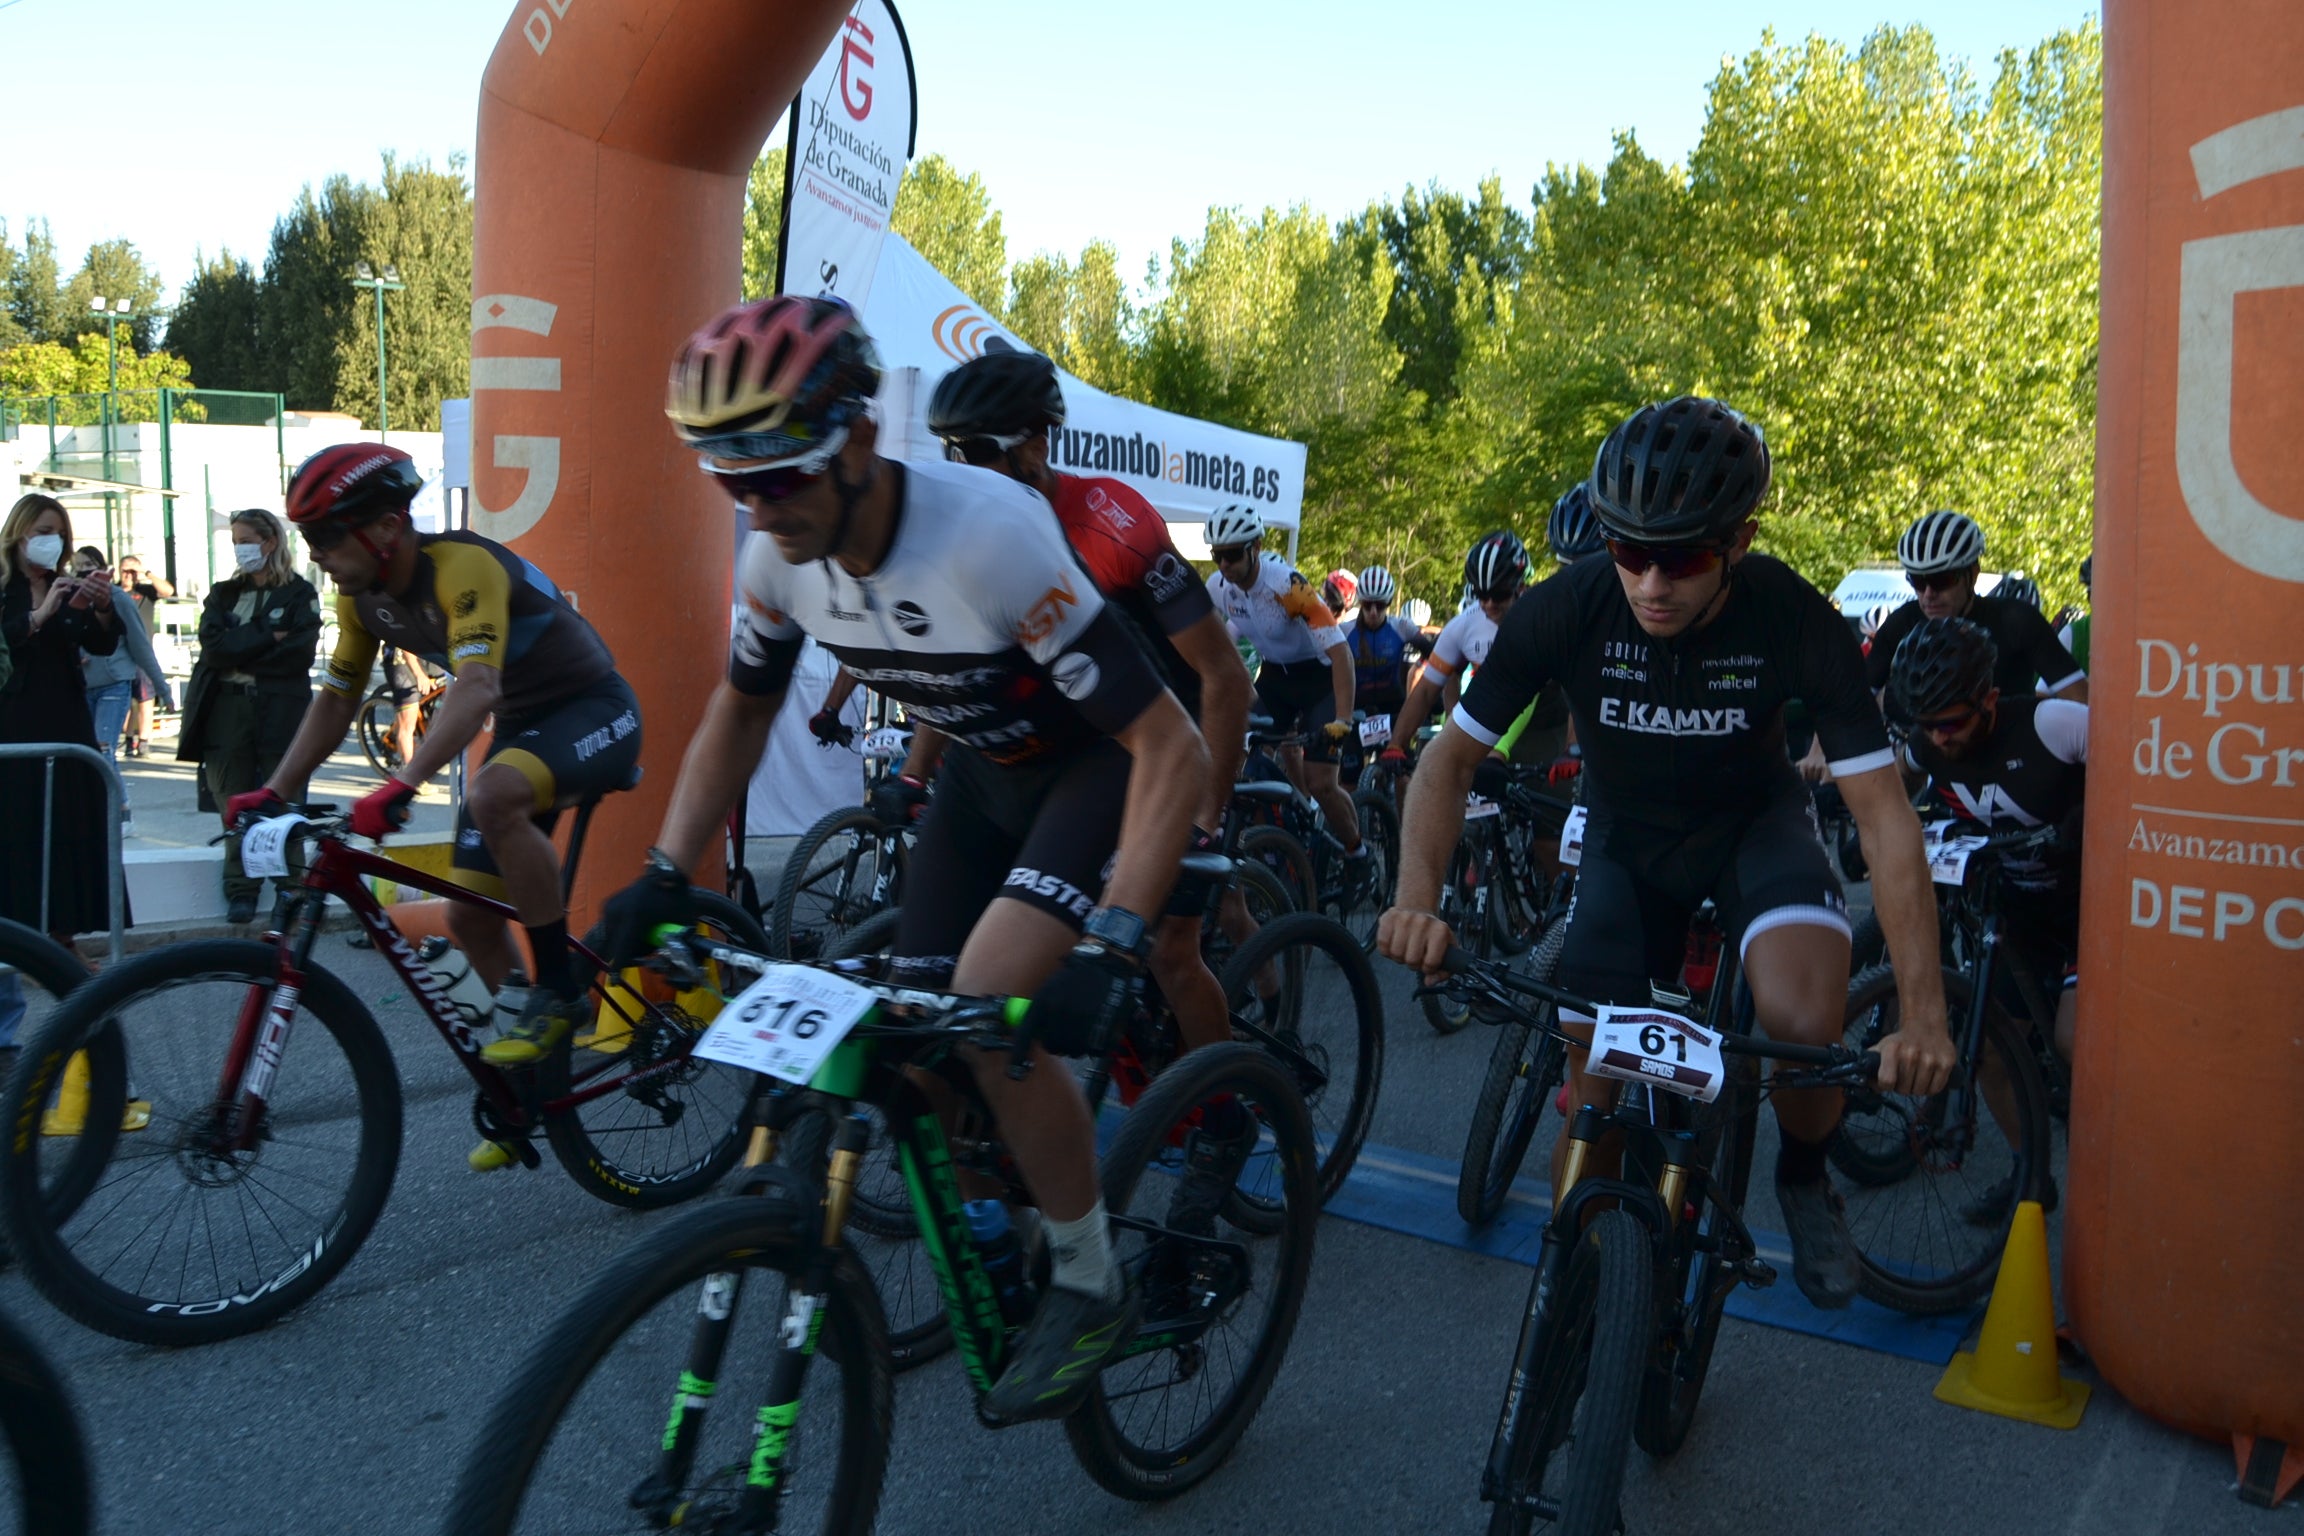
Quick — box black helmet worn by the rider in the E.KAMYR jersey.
[1590,394,1769,546]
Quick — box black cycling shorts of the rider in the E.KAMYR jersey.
[1560,790,1848,1006]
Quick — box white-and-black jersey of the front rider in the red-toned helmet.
[728,461,1161,762]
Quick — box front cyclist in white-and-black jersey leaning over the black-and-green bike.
[606,297,1207,1419]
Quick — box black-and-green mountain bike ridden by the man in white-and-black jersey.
[445,937,1318,1536]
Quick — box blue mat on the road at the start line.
[1327,1142,1981,1366]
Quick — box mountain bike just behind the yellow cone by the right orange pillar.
[1829,827,2062,1315]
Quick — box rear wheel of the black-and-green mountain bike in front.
[1064,1043,1320,1499]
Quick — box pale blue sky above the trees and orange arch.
[0,0,2097,303]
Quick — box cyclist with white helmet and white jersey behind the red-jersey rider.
[1207,502,1369,868]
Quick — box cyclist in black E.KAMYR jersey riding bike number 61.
[1378,396,1954,1306]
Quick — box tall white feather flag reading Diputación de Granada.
[783,0,919,309]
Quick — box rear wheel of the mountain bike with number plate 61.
[1631,1050,1760,1455]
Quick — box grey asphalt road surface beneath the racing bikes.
[0,937,2276,1536]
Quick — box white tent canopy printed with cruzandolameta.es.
[864,235,1304,529]
